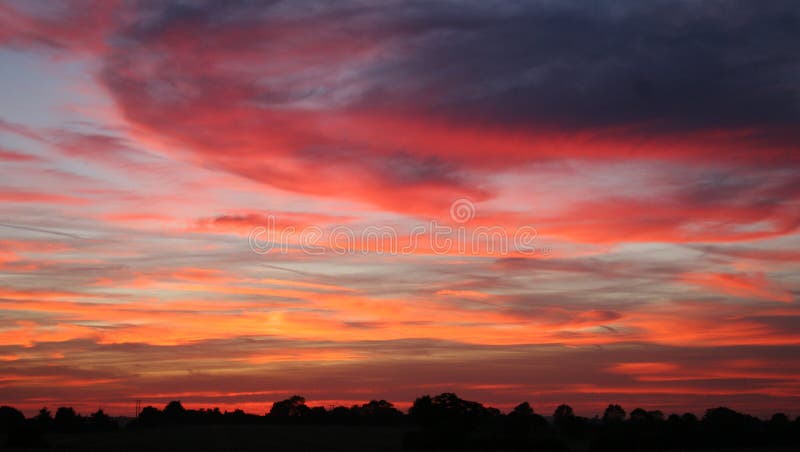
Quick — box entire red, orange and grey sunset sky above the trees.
[0,0,800,416]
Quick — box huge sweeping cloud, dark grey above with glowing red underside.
[61,3,798,217]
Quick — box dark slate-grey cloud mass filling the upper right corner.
[358,1,800,130]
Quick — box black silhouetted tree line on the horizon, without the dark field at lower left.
[0,393,800,450]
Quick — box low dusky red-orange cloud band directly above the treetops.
[0,338,798,415]
